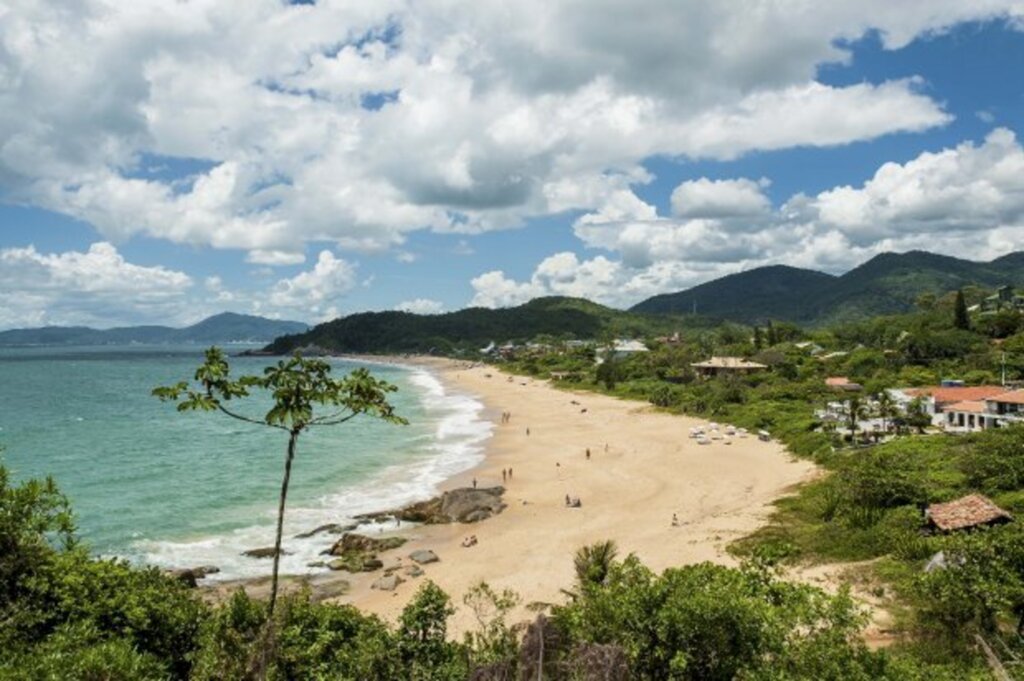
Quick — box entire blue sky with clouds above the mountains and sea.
[0,0,1024,329]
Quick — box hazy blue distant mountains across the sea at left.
[0,312,309,346]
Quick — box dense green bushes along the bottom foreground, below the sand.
[0,468,969,681]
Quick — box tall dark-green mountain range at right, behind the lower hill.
[632,251,1024,325]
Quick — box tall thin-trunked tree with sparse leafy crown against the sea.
[153,347,407,614]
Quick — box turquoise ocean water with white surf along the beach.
[0,346,492,580]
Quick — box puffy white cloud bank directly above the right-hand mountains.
[472,128,1024,306]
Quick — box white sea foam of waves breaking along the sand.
[130,369,494,581]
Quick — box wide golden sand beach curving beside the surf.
[305,359,815,633]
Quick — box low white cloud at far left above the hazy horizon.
[0,243,193,328]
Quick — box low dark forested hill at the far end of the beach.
[260,297,696,353]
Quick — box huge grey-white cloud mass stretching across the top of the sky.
[0,0,1022,260]
